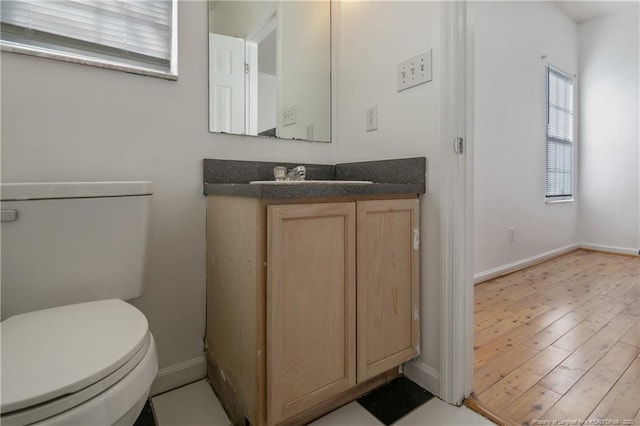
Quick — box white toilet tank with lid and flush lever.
[0,182,152,320]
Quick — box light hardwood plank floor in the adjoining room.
[472,250,640,425]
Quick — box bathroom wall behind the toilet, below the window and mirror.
[1,1,335,392]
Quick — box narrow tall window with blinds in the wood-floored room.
[545,67,574,201]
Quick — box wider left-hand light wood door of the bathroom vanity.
[267,203,356,424]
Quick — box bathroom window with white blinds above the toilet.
[0,0,177,79]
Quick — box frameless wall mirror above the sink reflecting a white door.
[209,0,331,142]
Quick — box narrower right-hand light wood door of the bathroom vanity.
[357,199,420,382]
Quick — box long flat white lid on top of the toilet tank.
[0,181,153,201]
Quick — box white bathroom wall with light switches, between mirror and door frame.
[332,2,441,392]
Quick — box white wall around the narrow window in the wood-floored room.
[471,2,580,274]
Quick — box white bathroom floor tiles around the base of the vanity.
[151,380,493,426]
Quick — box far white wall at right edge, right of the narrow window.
[578,6,640,254]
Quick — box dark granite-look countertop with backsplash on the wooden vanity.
[204,157,426,199]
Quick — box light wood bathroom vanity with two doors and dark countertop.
[204,158,425,425]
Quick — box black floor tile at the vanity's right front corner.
[358,376,433,426]
